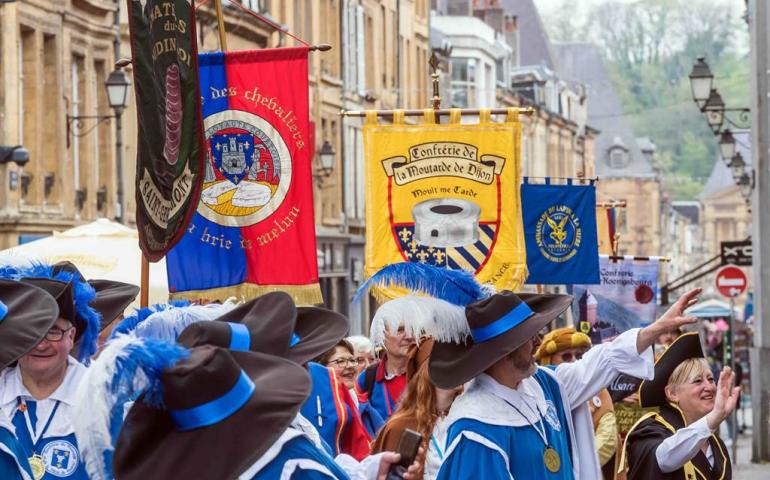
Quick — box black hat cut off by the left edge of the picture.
[0,280,59,370]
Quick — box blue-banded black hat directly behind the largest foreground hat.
[177,292,297,357]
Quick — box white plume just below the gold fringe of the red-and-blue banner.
[134,300,237,342]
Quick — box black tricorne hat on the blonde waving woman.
[639,332,705,407]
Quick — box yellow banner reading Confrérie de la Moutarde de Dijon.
[364,109,527,296]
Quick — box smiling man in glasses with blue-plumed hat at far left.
[0,264,138,480]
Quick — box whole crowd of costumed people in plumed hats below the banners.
[0,262,739,480]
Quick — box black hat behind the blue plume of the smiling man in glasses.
[53,261,139,330]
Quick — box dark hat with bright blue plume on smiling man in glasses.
[0,261,102,364]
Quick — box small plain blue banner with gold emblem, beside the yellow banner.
[521,178,599,285]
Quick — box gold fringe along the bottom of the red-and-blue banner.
[170,283,323,305]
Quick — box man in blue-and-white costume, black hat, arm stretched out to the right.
[429,289,700,480]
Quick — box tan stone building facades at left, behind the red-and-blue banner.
[0,0,430,332]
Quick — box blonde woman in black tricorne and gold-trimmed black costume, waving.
[623,332,740,480]
